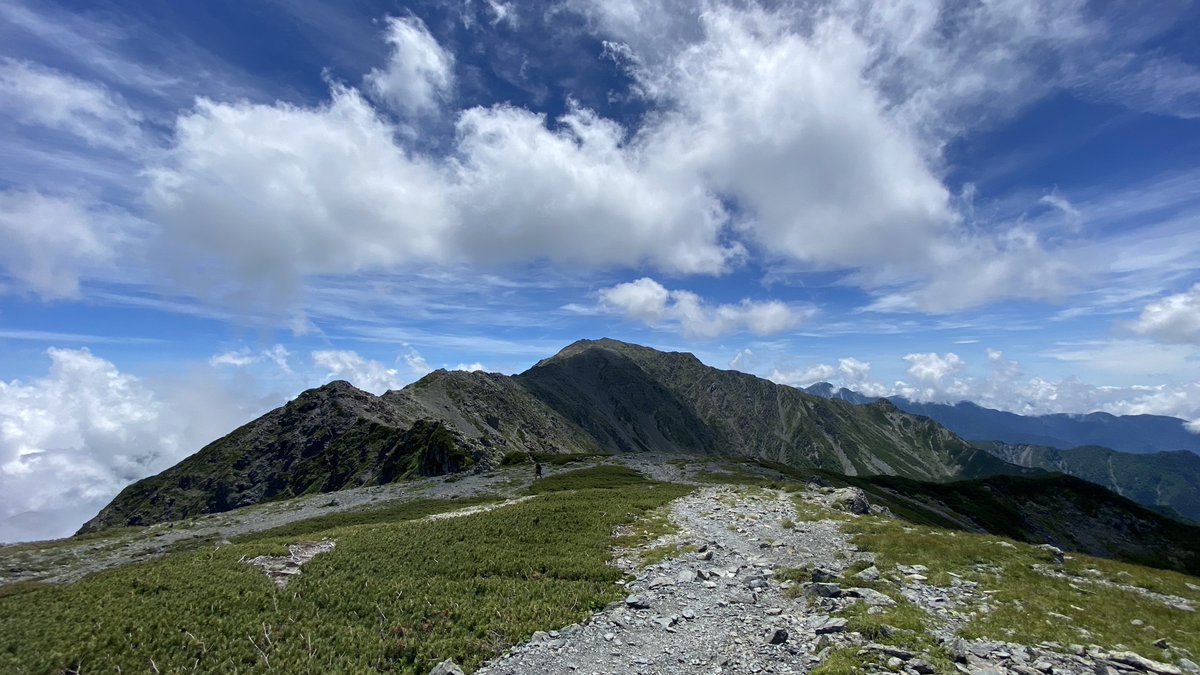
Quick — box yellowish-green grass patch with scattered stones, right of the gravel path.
[845,518,1200,659]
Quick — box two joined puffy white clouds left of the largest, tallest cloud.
[146,88,742,303]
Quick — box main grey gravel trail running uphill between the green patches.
[478,488,883,675]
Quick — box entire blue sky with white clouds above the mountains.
[0,0,1200,540]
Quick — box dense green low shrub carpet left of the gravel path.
[0,474,688,674]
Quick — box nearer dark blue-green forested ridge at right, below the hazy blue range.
[978,443,1200,521]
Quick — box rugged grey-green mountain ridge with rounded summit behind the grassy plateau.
[82,340,1028,532]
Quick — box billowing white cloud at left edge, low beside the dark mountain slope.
[0,348,184,540]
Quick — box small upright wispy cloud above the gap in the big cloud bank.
[364,17,454,114]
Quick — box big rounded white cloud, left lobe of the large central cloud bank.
[146,88,449,299]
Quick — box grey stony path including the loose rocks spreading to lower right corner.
[472,486,1200,675]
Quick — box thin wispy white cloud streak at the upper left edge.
[0,59,143,151]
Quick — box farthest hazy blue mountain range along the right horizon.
[804,382,1200,453]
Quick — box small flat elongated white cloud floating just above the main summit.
[599,277,814,338]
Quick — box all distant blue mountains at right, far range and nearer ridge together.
[805,382,1200,521]
